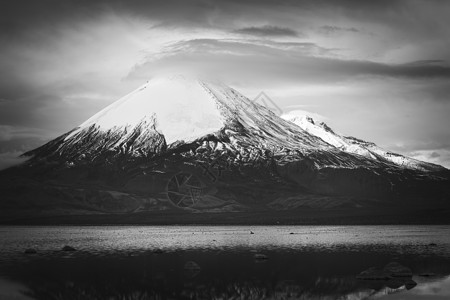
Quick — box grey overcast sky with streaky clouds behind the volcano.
[0,0,450,168]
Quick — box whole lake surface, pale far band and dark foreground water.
[0,226,450,300]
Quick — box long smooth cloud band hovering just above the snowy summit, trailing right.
[129,39,450,88]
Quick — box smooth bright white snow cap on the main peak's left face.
[65,75,224,143]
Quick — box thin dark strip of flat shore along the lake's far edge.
[0,210,450,226]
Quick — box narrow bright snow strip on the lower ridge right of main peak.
[282,114,443,171]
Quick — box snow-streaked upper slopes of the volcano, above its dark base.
[27,75,440,175]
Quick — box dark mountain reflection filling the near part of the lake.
[5,252,450,300]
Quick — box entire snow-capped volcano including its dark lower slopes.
[0,75,450,223]
